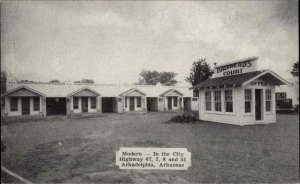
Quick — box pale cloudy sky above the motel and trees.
[1,0,299,85]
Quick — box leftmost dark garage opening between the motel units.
[46,98,67,116]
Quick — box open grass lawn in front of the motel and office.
[1,113,299,183]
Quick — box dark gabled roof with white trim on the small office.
[191,70,289,89]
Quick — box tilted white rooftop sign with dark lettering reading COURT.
[214,57,258,77]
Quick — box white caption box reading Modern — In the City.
[116,147,191,170]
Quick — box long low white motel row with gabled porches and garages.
[2,78,198,117]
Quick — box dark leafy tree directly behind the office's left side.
[185,58,214,96]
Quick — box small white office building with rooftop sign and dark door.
[193,57,289,125]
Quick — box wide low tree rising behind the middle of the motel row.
[137,70,177,86]
